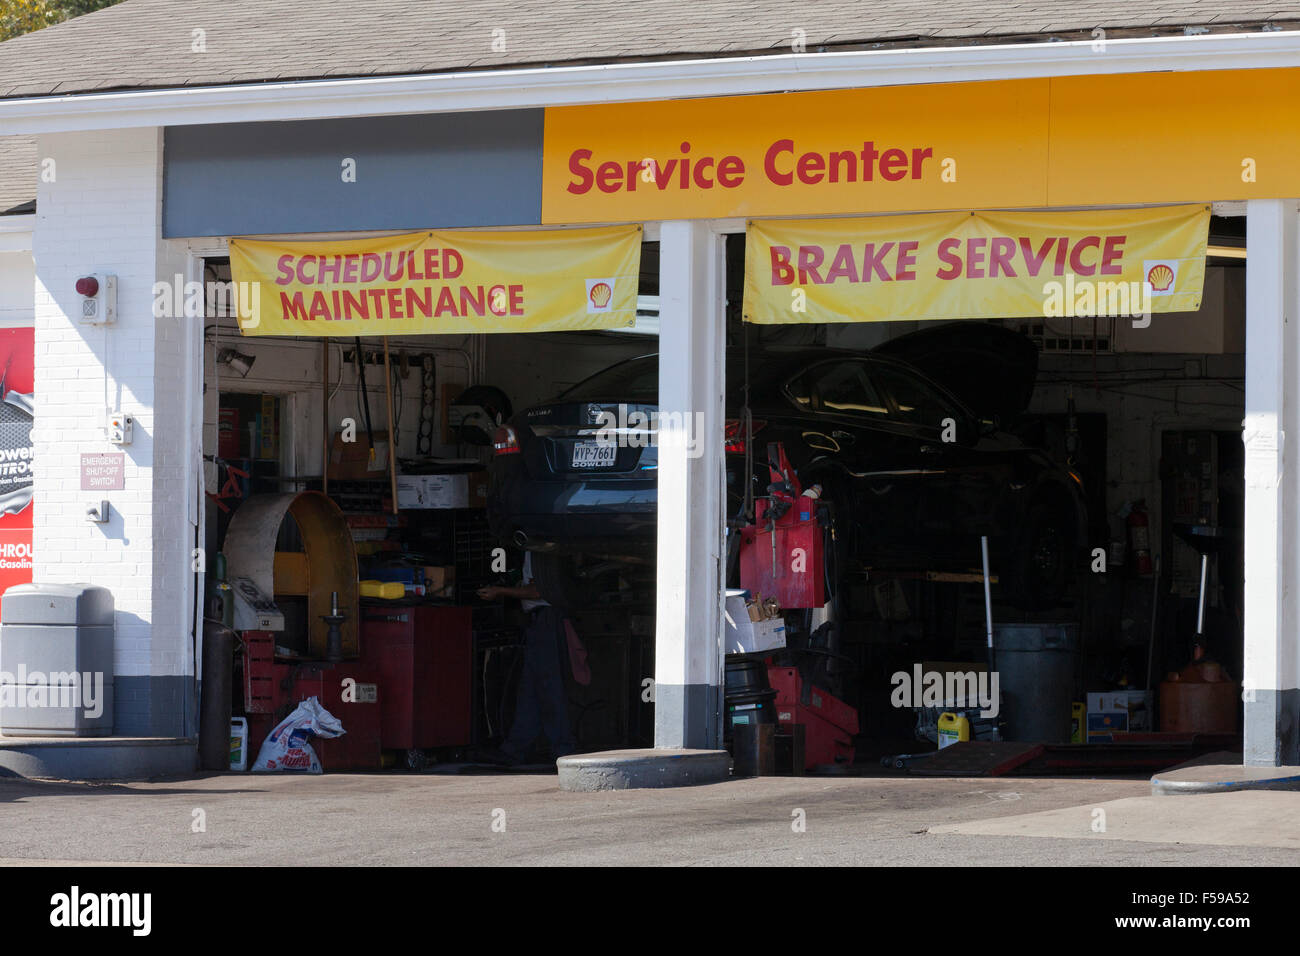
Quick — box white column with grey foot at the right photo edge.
[1242,199,1300,766]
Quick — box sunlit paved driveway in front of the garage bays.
[0,774,1300,866]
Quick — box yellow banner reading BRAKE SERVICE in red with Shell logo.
[745,206,1210,325]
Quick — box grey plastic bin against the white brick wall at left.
[0,584,114,737]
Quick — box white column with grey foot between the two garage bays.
[654,221,725,749]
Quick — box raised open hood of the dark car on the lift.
[872,320,1039,421]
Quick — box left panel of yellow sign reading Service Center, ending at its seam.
[542,79,1049,224]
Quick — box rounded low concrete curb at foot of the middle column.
[555,749,731,793]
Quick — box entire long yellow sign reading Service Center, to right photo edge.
[542,69,1300,224]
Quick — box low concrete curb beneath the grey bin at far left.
[0,737,199,780]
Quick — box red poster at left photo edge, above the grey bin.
[0,329,35,613]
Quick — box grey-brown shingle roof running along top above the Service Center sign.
[0,0,1300,98]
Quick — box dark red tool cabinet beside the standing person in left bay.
[360,605,473,750]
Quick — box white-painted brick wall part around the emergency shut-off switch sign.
[33,129,198,697]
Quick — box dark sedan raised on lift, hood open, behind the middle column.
[488,324,1087,607]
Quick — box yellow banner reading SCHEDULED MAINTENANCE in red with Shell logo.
[230,226,641,336]
